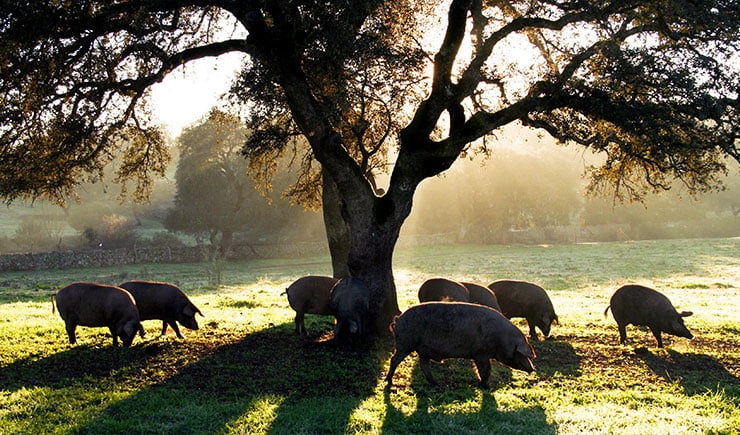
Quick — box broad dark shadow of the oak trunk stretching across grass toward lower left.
[56,324,382,433]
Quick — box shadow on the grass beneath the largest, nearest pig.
[382,387,557,434]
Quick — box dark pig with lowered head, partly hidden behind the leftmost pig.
[120,281,203,338]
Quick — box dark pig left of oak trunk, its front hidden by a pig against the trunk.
[285,276,339,335]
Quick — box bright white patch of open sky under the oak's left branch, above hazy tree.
[151,54,242,138]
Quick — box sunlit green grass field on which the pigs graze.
[0,239,740,434]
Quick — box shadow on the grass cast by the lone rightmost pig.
[635,349,740,395]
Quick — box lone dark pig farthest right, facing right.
[604,285,694,347]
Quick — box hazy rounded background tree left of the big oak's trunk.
[164,109,328,259]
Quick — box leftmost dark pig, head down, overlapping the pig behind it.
[51,282,144,347]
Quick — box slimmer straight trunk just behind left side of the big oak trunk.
[321,169,351,278]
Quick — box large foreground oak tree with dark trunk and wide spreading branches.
[0,0,740,338]
